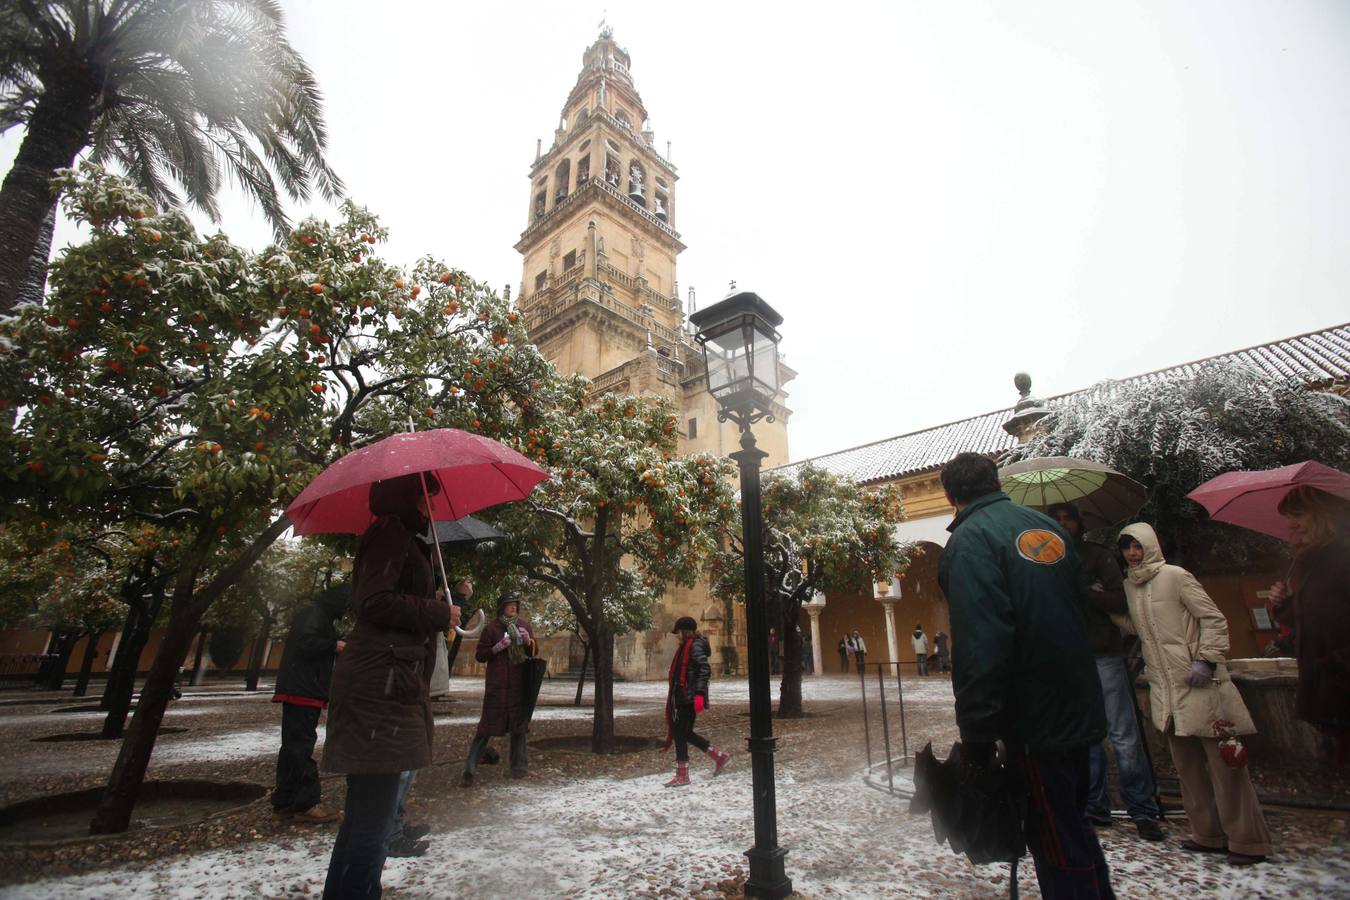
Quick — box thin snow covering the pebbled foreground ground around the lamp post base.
[0,756,1350,900]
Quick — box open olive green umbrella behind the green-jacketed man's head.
[999,456,1149,528]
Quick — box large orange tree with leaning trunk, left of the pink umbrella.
[0,167,552,833]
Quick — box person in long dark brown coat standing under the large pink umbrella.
[323,474,459,900]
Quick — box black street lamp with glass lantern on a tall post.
[689,291,792,897]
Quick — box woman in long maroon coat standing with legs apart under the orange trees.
[460,591,539,788]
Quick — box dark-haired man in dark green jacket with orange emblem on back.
[938,453,1115,900]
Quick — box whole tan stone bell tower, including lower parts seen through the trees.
[516,28,795,677]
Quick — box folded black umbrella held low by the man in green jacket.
[910,741,1026,897]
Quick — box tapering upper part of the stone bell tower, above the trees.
[516,30,687,380]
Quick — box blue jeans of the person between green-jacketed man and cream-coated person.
[1088,656,1158,819]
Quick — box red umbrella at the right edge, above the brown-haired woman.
[1187,461,1350,541]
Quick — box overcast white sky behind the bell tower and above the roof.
[0,0,1350,459]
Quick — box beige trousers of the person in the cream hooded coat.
[1168,734,1270,857]
